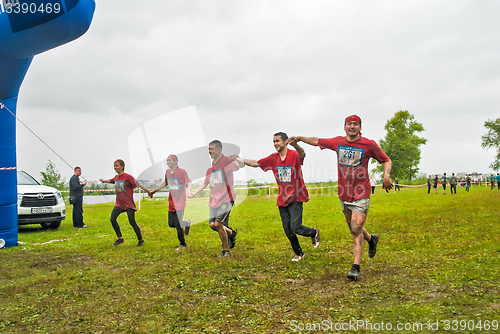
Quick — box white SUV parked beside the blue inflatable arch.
[17,170,66,229]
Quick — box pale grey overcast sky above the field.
[13,0,500,182]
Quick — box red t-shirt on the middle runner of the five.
[204,156,239,208]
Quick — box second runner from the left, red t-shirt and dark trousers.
[150,154,192,250]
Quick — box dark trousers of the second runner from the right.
[278,202,316,255]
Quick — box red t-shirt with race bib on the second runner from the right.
[257,149,309,206]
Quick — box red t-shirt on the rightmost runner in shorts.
[318,136,390,202]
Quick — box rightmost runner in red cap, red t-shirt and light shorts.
[290,115,393,281]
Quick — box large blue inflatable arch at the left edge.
[0,0,95,247]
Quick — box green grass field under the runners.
[0,186,500,333]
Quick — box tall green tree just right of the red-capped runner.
[376,110,427,180]
